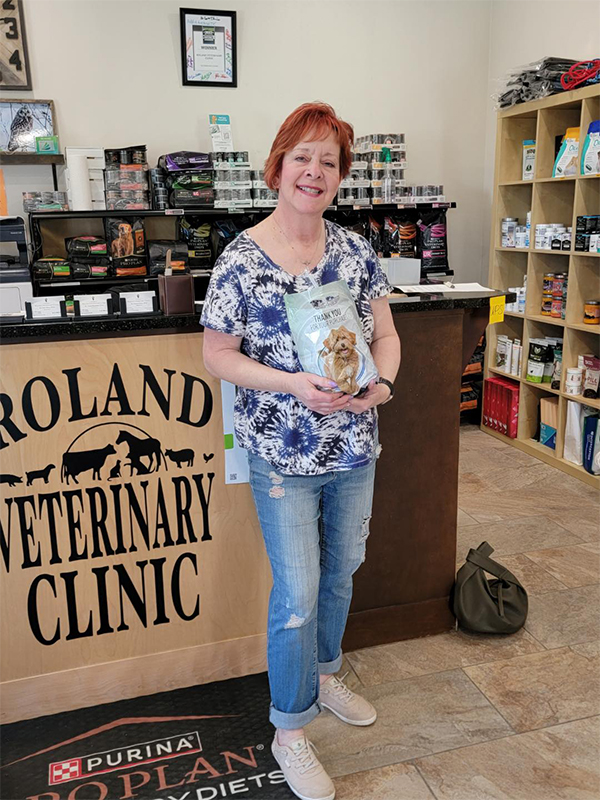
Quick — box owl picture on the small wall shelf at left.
[0,98,56,155]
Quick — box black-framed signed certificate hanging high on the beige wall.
[179,8,237,87]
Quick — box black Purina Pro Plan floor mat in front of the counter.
[0,673,294,800]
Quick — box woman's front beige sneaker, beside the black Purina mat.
[271,733,335,800]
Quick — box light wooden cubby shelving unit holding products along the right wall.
[481,85,600,489]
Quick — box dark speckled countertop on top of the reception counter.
[0,291,516,344]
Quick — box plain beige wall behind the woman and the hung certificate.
[5,0,597,280]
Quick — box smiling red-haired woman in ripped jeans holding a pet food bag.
[201,103,400,800]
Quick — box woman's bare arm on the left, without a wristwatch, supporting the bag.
[203,327,350,414]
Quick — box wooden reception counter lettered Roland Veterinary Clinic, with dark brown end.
[0,294,504,722]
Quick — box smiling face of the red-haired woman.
[278,134,340,214]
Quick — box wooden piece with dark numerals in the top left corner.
[0,0,31,91]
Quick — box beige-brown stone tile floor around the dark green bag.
[308,426,600,800]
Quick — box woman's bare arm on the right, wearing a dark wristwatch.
[348,297,401,414]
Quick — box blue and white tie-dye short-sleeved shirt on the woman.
[200,221,392,475]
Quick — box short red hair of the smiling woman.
[265,102,354,189]
